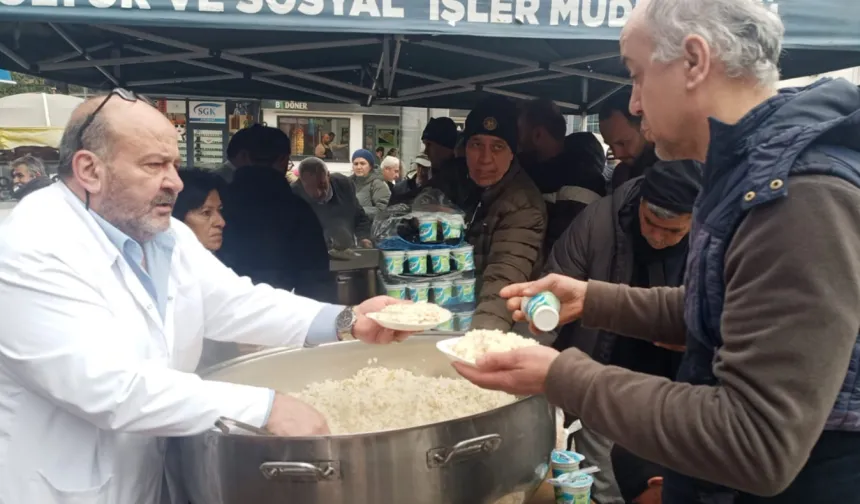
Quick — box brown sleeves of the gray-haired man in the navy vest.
[546,176,860,495]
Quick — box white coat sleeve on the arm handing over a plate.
[177,229,330,346]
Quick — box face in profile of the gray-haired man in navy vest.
[624,1,707,160]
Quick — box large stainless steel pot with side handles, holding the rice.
[180,336,555,504]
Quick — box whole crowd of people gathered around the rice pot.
[0,0,860,504]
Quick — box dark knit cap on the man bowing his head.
[641,160,702,214]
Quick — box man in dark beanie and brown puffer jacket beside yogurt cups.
[455,97,547,331]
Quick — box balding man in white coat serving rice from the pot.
[0,90,406,504]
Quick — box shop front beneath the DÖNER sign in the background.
[262,100,403,173]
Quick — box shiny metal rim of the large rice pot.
[198,338,549,441]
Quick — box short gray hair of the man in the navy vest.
[645,0,785,87]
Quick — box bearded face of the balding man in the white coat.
[82,102,182,242]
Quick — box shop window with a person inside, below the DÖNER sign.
[278,116,350,163]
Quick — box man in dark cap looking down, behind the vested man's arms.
[547,161,702,504]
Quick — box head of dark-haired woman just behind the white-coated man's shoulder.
[173,169,226,252]
